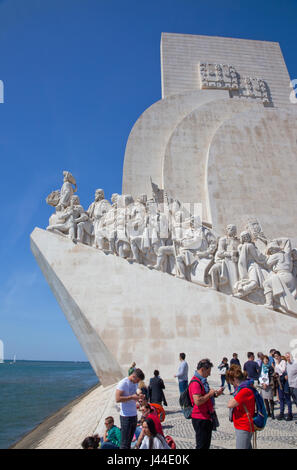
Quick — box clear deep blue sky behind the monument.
[0,0,297,360]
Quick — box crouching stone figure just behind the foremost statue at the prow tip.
[47,195,88,242]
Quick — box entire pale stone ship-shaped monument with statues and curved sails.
[31,33,297,385]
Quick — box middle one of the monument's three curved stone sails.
[163,98,263,220]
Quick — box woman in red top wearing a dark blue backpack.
[226,367,256,449]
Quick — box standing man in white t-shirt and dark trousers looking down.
[116,369,144,449]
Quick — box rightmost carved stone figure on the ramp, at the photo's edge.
[263,238,297,313]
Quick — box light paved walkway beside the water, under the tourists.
[15,381,297,449]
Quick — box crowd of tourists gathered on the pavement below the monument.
[82,349,297,449]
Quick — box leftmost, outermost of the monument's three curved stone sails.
[122,90,229,197]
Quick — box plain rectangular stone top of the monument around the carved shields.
[161,33,291,107]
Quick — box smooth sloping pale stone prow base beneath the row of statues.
[31,228,297,385]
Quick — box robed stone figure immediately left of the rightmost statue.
[234,231,268,297]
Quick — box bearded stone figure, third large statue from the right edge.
[209,224,240,292]
